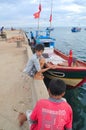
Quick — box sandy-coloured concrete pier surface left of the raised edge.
[0,30,32,130]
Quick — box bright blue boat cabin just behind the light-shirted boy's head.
[29,28,56,53]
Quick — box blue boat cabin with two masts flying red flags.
[29,0,56,49]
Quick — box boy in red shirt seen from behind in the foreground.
[19,79,72,130]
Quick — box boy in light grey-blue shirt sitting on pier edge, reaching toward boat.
[23,44,54,79]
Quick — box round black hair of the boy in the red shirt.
[49,79,66,96]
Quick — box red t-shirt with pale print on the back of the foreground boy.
[30,99,72,130]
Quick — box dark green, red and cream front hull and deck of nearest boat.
[43,48,86,88]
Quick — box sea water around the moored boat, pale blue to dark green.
[27,27,86,130]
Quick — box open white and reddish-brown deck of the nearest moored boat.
[43,47,86,70]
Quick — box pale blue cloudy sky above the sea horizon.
[0,0,86,27]
